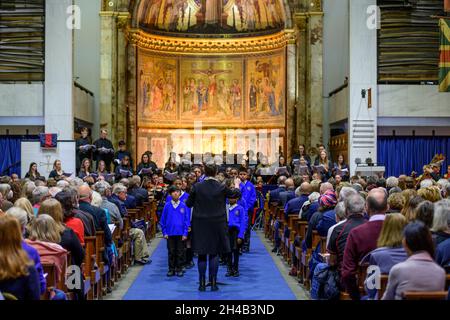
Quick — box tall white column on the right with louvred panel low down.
[348,0,378,174]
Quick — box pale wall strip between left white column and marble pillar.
[74,0,101,137]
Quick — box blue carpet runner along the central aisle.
[123,233,296,300]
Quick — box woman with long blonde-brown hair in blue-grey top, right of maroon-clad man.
[361,213,407,298]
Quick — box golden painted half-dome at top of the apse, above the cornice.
[139,0,285,34]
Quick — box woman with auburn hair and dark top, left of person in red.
[38,199,84,266]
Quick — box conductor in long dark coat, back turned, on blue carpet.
[186,164,240,291]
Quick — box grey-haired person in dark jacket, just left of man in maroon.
[327,194,366,271]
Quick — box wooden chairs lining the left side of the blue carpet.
[41,200,157,300]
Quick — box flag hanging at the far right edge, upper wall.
[439,19,450,92]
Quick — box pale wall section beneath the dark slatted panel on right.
[378,85,450,117]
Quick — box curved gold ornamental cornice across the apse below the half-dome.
[127,29,292,56]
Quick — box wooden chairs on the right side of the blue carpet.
[264,201,450,300]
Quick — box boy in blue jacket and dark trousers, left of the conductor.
[160,186,190,277]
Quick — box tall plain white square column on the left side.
[44,0,73,140]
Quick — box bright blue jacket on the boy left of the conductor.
[160,201,190,237]
